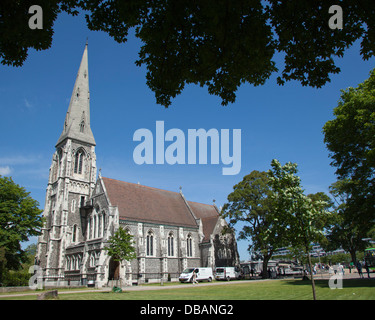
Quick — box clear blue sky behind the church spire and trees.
[0,14,375,260]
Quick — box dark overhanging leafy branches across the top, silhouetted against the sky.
[0,0,375,107]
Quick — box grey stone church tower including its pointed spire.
[37,43,96,282]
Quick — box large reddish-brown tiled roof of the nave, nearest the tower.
[102,177,197,227]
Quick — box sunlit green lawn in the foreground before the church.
[0,279,375,300]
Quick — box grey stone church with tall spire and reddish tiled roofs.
[36,44,239,287]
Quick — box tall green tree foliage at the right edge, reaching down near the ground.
[323,65,375,262]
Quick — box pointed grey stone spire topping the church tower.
[56,41,96,146]
